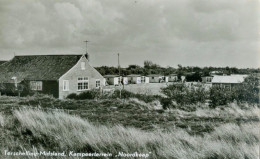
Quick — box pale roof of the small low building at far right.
[212,75,247,83]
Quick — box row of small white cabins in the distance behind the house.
[104,74,178,85]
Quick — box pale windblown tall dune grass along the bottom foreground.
[0,109,260,159]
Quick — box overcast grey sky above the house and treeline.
[0,0,260,67]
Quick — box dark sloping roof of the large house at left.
[0,55,82,83]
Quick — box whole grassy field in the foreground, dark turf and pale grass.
[0,95,260,159]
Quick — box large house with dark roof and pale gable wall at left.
[0,55,105,99]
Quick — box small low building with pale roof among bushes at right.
[212,75,247,89]
